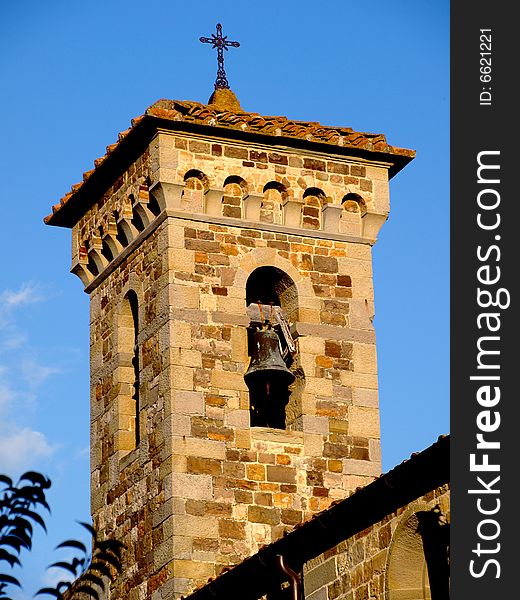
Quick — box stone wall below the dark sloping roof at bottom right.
[303,485,450,600]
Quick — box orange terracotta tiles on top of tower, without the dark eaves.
[44,99,415,225]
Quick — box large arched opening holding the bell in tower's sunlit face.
[244,266,304,430]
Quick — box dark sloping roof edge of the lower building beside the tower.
[182,435,450,600]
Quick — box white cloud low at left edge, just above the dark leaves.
[0,427,55,474]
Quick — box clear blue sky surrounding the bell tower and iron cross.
[0,0,449,599]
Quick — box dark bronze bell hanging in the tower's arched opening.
[244,329,295,395]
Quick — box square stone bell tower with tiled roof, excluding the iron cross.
[45,81,414,600]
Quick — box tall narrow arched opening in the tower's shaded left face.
[118,290,141,448]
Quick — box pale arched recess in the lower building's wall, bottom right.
[385,502,435,600]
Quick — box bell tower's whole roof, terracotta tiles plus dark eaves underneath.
[44,99,415,227]
